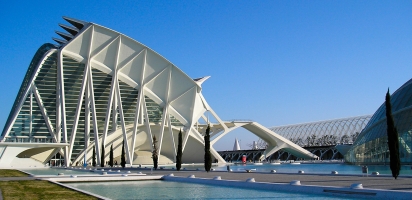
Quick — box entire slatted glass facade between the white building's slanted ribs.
[3,44,183,160]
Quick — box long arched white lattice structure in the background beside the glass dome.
[269,115,372,147]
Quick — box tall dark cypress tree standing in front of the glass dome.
[385,89,401,179]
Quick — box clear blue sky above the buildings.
[0,0,412,150]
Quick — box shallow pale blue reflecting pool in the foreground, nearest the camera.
[65,181,351,199]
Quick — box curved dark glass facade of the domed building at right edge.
[345,79,412,164]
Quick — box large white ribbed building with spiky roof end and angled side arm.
[0,17,316,167]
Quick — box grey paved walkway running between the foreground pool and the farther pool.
[0,168,412,200]
